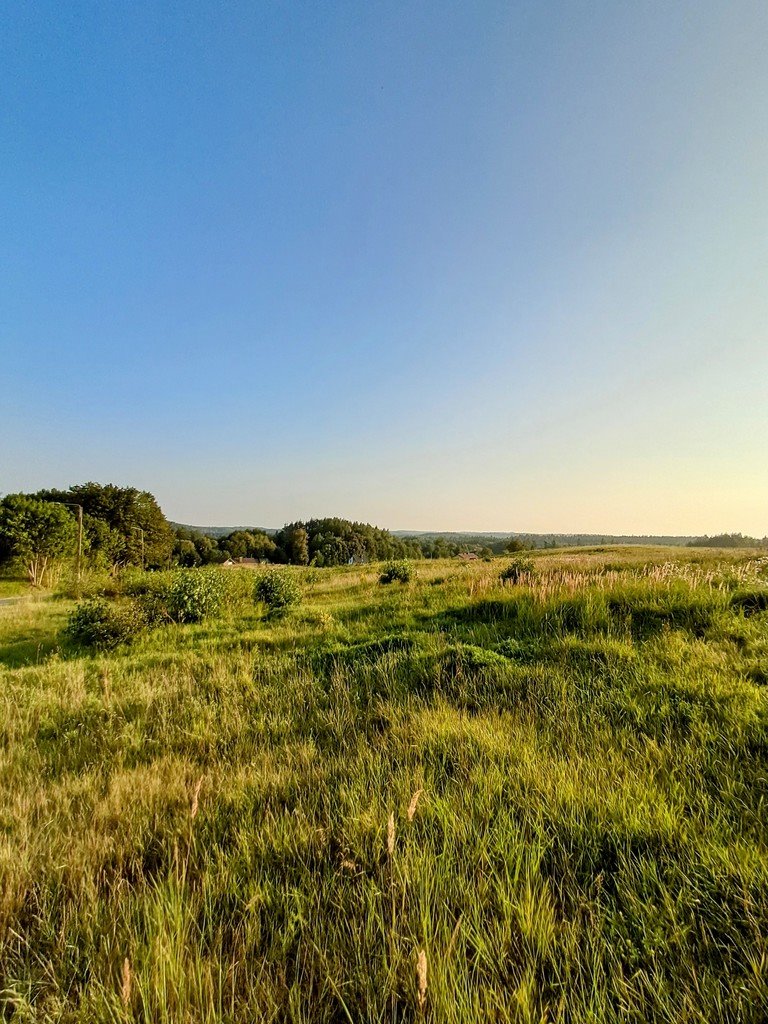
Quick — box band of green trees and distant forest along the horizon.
[0,482,768,583]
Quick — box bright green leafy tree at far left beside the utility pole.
[0,495,77,587]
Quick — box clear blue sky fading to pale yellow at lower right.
[0,0,768,536]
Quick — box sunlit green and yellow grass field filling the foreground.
[0,549,768,1024]
